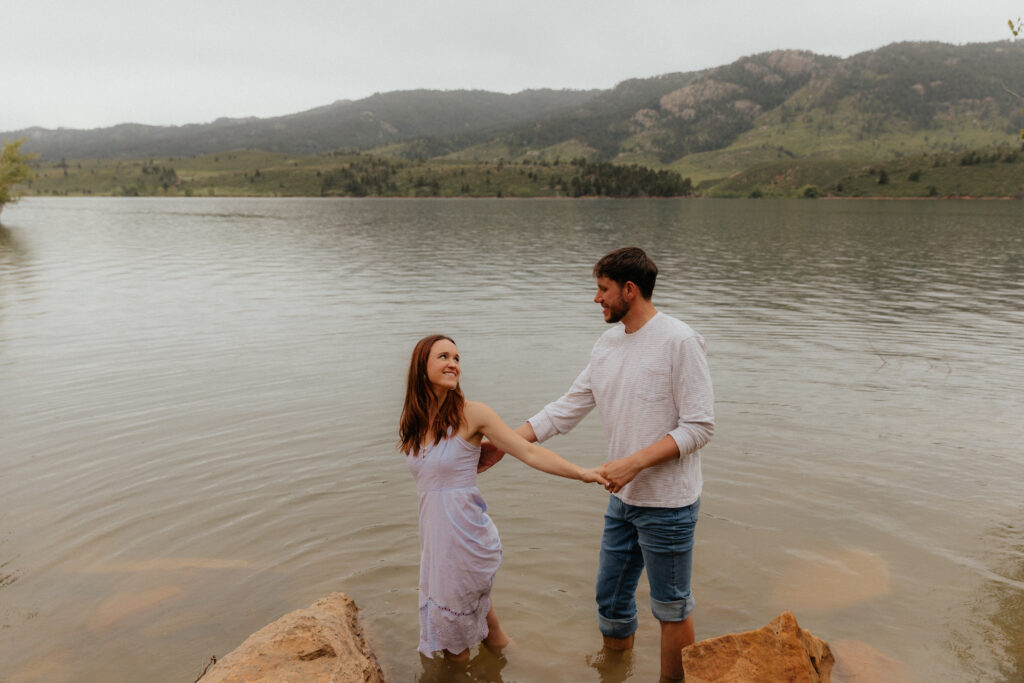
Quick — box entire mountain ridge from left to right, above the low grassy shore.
[9,41,1024,180]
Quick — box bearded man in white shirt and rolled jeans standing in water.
[480,247,715,679]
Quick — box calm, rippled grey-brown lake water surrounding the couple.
[0,199,1024,683]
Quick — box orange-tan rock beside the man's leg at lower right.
[683,611,836,683]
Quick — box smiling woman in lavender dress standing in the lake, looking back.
[398,335,605,661]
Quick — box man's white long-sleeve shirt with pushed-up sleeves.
[529,312,715,508]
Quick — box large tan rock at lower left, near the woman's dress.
[200,593,384,683]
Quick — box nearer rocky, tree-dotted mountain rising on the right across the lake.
[370,42,1024,180]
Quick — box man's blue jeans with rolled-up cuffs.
[597,496,700,638]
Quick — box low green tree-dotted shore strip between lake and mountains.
[24,147,1024,199]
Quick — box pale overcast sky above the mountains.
[0,0,1024,131]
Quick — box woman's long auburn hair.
[398,335,466,456]
